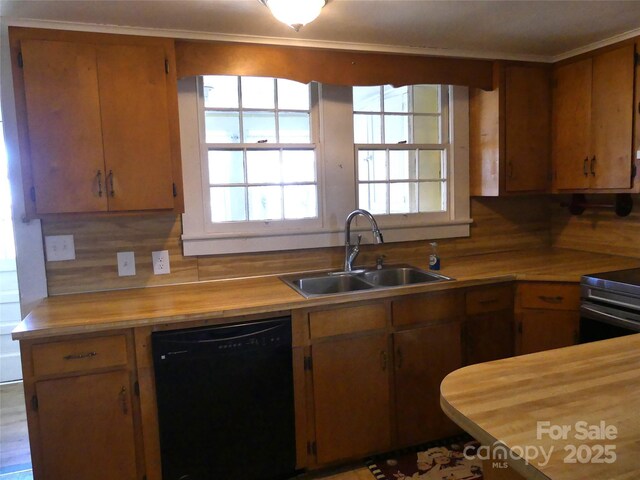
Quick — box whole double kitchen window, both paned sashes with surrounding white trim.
[179,76,471,255]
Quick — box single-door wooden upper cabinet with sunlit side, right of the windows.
[469,65,551,196]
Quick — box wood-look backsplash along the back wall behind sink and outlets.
[42,197,551,295]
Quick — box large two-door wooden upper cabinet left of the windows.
[10,28,183,216]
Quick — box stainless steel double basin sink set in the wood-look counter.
[280,265,453,298]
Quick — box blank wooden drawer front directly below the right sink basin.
[392,292,464,326]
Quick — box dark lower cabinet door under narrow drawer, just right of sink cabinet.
[465,310,514,364]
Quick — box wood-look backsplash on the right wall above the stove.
[550,195,640,258]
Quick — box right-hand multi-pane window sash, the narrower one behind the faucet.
[353,85,449,215]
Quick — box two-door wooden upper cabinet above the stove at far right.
[552,44,635,191]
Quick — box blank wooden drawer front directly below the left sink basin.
[309,303,387,338]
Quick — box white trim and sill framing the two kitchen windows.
[178,78,472,256]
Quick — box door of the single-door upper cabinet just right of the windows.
[505,66,551,192]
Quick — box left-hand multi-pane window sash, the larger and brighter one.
[200,76,318,231]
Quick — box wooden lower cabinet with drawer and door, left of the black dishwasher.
[20,331,146,480]
